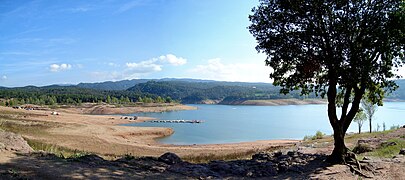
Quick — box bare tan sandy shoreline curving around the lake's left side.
[0,107,299,156]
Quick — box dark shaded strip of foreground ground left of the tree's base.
[0,152,344,179]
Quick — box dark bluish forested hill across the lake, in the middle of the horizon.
[128,80,312,104]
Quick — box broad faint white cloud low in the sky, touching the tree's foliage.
[189,58,271,82]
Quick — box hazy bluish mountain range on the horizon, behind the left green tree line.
[0,78,405,104]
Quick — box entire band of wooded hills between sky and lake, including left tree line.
[0,79,405,105]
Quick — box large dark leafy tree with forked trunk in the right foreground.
[249,0,405,163]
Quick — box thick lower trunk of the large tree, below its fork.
[328,125,348,164]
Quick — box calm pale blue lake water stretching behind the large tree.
[122,102,405,144]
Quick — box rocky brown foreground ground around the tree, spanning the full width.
[0,128,405,179]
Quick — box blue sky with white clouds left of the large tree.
[0,0,270,87]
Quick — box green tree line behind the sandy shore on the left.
[0,86,175,106]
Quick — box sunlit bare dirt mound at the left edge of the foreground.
[0,130,32,153]
